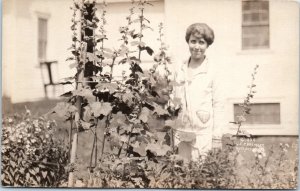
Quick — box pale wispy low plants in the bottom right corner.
[236,143,298,189]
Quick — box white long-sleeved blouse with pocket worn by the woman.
[175,58,226,139]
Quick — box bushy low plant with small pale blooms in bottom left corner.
[1,109,68,187]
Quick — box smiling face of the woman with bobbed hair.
[188,34,208,60]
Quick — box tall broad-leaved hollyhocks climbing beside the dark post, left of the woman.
[52,1,179,176]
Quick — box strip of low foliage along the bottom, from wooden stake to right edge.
[65,142,297,189]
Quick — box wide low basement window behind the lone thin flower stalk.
[234,103,280,124]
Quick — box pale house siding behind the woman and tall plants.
[2,0,299,135]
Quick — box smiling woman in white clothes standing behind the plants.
[175,23,225,160]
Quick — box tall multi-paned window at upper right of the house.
[242,0,270,50]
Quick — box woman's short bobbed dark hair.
[185,23,215,45]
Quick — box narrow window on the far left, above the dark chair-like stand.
[38,18,47,60]
